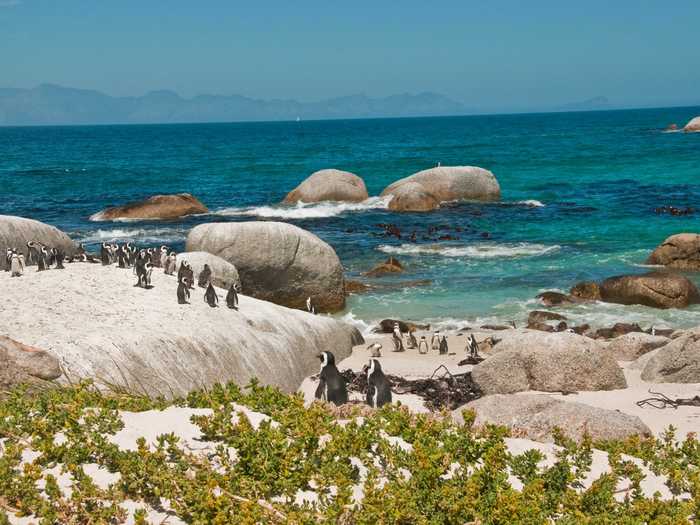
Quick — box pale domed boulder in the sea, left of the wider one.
[284,169,369,204]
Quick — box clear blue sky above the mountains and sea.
[0,0,700,109]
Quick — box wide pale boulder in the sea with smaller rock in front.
[382,166,501,202]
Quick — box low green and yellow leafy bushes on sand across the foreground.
[0,382,700,525]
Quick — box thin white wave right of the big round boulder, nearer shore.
[377,242,561,259]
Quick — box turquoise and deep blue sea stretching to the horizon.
[0,107,700,332]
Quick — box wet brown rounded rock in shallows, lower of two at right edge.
[600,272,700,308]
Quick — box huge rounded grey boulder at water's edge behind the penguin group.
[186,222,345,312]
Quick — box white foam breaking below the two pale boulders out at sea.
[213,197,391,219]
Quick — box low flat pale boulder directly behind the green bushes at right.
[453,394,651,442]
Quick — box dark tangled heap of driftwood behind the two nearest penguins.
[341,365,481,411]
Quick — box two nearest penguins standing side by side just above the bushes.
[315,352,391,408]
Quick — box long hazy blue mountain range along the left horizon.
[0,84,468,126]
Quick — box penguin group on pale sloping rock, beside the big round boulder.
[100,242,239,310]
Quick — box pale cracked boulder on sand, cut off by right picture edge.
[642,331,700,383]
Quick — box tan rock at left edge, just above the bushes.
[0,335,62,390]
